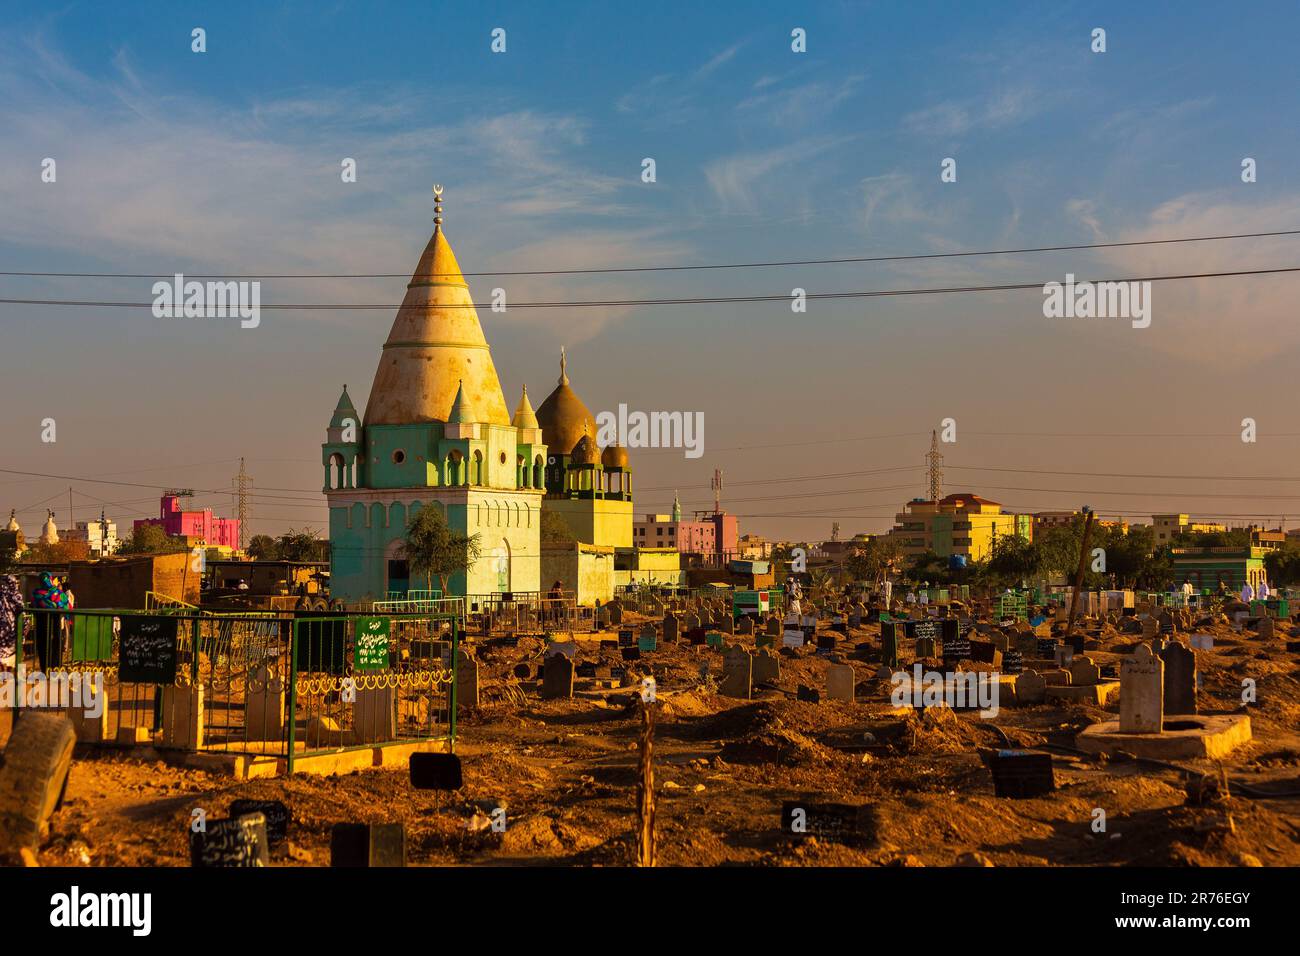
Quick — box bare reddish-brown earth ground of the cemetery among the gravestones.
[0,613,1300,866]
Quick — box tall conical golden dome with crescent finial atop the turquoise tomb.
[365,189,510,425]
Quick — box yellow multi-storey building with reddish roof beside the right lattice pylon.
[889,494,1034,561]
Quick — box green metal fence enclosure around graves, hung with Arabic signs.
[3,605,463,773]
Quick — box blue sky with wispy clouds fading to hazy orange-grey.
[0,3,1300,541]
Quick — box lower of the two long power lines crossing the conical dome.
[0,265,1300,312]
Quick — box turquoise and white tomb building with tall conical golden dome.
[321,191,549,601]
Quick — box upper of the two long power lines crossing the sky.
[0,229,1300,280]
